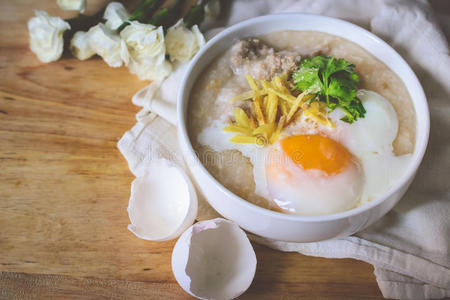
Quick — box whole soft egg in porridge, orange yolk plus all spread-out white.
[266,90,410,215]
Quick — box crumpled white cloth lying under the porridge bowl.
[118,0,450,299]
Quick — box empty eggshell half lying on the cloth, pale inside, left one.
[127,159,198,241]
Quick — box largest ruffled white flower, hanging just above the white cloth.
[120,21,172,81]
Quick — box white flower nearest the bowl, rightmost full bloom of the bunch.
[166,19,205,62]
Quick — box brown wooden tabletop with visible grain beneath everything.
[0,0,381,299]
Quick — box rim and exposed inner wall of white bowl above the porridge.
[177,13,429,221]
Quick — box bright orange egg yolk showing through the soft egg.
[280,134,352,175]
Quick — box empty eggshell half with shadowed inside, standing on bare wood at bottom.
[172,218,256,300]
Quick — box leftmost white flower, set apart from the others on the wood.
[28,10,70,62]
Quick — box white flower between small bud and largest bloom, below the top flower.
[87,23,129,68]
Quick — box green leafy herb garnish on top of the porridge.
[292,55,366,123]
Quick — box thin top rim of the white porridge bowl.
[177,13,430,222]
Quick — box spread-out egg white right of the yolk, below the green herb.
[330,90,412,204]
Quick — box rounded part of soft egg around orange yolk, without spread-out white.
[266,134,364,215]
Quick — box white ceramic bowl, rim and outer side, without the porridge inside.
[177,14,430,242]
